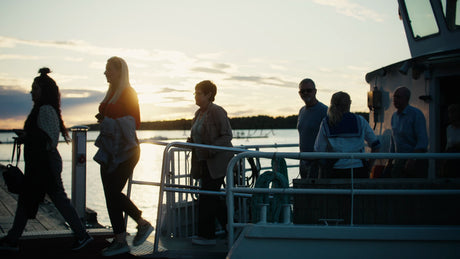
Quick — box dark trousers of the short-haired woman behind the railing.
[198,161,227,239]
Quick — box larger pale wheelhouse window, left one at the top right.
[405,0,438,39]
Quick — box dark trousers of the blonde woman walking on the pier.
[101,148,142,234]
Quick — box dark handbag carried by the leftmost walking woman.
[3,138,24,194]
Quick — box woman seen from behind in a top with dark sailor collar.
[314,92,380,178]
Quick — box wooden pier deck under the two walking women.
[0,164,153,258]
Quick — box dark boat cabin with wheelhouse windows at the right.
[366,0,460,175]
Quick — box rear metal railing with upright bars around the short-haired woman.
[125,140,298,251]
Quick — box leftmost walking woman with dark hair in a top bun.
[0,68,93,253]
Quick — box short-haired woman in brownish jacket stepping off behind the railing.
[189,80,233,245]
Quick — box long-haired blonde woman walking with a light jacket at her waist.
[94,57,153,256]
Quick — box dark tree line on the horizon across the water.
[87,112,369,131]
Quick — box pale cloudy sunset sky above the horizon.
[0,0,410,129]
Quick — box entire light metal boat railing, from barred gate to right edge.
[128,141,460,255]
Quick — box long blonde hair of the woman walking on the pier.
[102,57,131,103]
